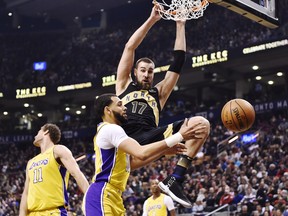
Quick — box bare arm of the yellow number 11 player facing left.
[54,145,89,193]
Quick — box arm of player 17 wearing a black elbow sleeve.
[156,21,186,109]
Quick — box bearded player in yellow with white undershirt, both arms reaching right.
[83,93,195,216]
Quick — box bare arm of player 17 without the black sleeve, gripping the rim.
[115,5,161,95]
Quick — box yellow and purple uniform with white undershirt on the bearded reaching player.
[83,123,130,216]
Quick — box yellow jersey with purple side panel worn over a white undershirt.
[93,123,130,192]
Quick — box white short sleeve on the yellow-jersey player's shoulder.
[96,124,129,149]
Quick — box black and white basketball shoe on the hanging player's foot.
[158,175,192,208]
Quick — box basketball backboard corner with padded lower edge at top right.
[209,0,279,28]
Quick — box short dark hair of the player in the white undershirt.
[94,93,117,123]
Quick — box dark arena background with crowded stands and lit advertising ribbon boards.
[0,0,288,216]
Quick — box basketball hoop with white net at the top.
[153,0,209,21]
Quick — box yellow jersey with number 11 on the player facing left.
[27,146,69,211]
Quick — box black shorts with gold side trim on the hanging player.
[124,120,184,145]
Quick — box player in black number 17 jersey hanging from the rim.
[116,5,210,207]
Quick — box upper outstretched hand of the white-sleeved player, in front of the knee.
[179,118,206,141]
